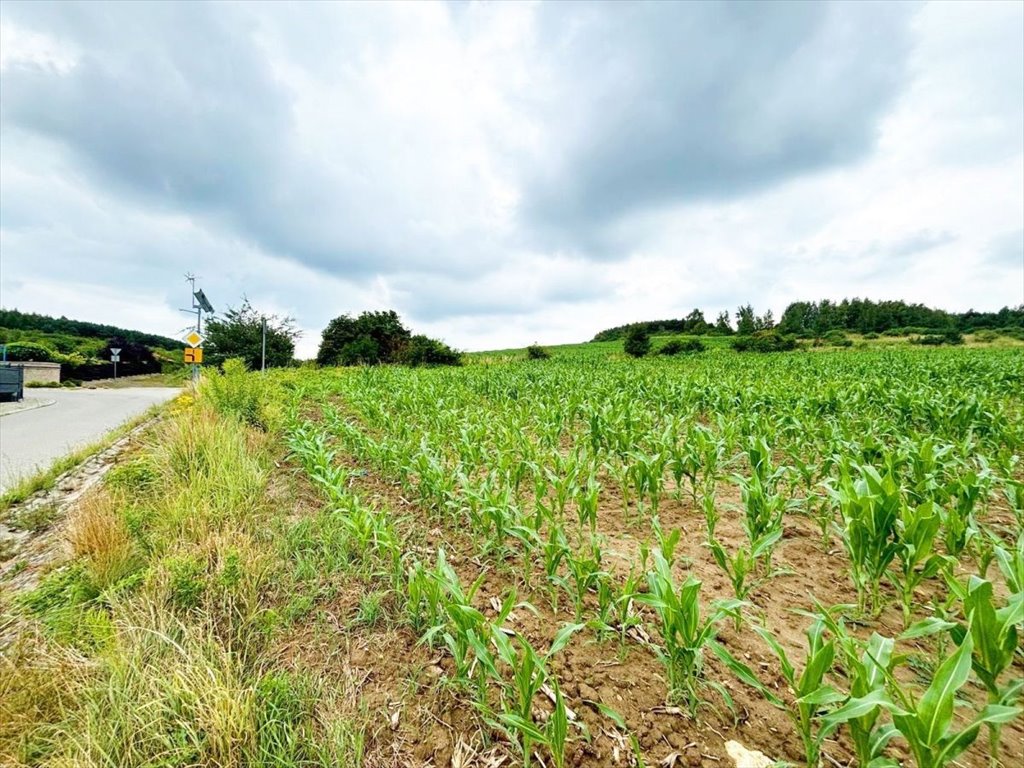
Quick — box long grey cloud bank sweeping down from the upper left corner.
[2,3,497,275]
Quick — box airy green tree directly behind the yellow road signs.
[205,296,301,371]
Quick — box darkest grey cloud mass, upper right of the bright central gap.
[525,3,912,249]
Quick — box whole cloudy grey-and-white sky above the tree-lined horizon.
[0,0,1024,357]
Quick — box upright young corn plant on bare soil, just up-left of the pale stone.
[634,551,739,717]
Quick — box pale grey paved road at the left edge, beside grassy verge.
[0,387,181,493]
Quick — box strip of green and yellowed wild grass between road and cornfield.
[0,368,368,768]
